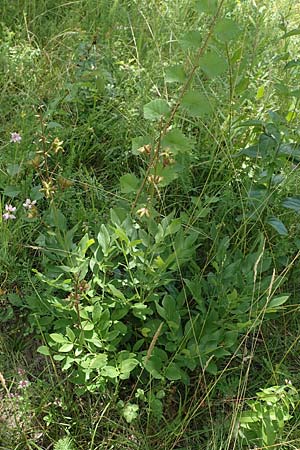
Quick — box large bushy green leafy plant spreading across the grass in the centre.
[28,210,289,391]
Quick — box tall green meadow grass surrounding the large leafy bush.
[0,0,300,450]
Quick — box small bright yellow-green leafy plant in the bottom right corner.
[237,382,298,447]
